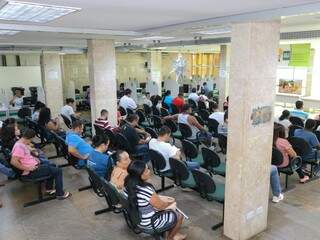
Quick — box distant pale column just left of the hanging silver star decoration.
[150,51,162,96]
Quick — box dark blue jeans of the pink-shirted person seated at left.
[21,164,64,196]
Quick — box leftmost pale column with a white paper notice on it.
[40,53,63,117]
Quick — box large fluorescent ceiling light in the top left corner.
[0,1,81,23]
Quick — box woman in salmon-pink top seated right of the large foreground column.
[273,124,309,183]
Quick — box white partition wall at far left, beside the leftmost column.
[0,66,42,106]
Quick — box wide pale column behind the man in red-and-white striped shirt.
[88,40,117,125]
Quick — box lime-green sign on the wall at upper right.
[289,43,311,67]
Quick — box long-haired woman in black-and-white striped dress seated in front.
[125,161,186,240]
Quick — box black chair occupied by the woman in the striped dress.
[119,190,178,240]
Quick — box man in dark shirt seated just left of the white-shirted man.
[122,114,150,163]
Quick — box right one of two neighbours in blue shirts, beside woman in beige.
[87,135,112,178]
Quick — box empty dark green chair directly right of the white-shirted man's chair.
[169,158,197,189]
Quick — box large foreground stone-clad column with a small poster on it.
[224,21,280,240]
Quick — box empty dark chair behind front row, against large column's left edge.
[201,147,226,177]
